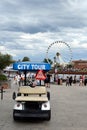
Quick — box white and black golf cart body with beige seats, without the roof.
[13,86,51,121]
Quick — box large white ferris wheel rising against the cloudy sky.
[46,41,72,65]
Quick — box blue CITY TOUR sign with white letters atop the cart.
[13,62,51,71]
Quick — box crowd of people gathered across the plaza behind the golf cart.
[14,72,87,88]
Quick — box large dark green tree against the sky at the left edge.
[0,53,14,71]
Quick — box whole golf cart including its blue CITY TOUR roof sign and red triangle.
[13,62,51,121]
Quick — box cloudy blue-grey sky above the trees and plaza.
[0,0,87,61]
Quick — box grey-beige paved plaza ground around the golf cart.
[0,79,87,130]
